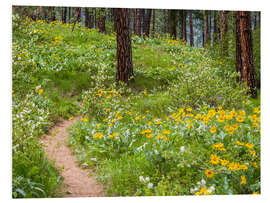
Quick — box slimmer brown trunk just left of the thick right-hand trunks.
[220,11,229,56]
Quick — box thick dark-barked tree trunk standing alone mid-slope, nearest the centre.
[116,8,133,82]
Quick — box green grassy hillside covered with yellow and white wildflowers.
[12,16,260,197]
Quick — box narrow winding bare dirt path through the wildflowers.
[42,117,105,197]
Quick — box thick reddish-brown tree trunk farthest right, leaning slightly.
[239,11,257,97]
